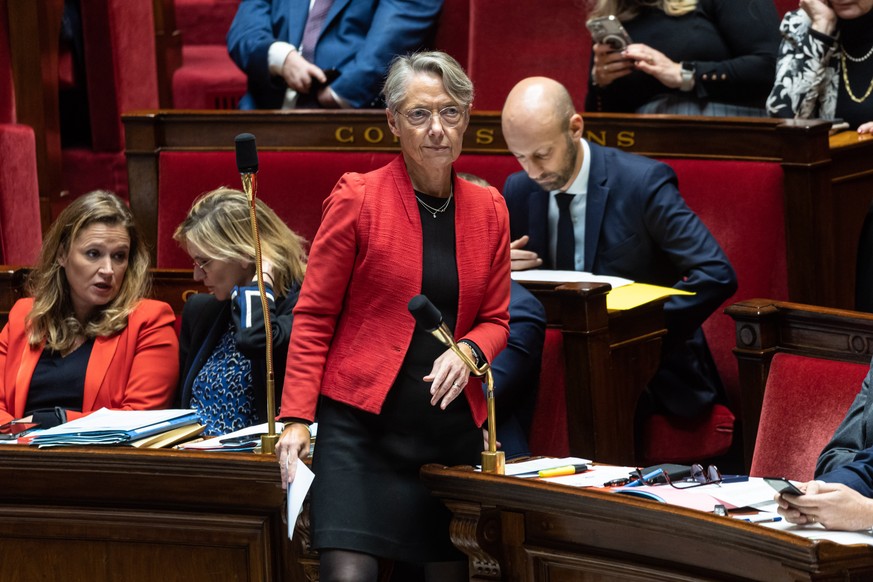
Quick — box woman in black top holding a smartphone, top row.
[585,0,779,117]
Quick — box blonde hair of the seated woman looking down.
[173,187,306,296]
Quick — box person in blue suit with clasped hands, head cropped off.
[227,0,443,109]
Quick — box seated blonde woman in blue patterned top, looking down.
[173,188,306,435]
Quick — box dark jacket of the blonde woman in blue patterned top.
[176,286,300,422]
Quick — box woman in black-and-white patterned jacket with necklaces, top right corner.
[767,0,873,133]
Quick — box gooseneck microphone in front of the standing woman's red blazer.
[407,295,506,475]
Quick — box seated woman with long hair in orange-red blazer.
[0,191,179,428]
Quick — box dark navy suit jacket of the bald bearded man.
[503,143,737,417]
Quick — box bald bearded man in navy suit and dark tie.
[502,77,737,428]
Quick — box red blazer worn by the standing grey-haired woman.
[280,157,509,425]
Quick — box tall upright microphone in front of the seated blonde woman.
[234,133,279,454]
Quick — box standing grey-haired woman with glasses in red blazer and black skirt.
[277,52,510,580]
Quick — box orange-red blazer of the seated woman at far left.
[0,298,179,422]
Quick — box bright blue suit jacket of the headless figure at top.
[227,0,443,109]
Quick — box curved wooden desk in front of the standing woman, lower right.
[422,465,873,582]
